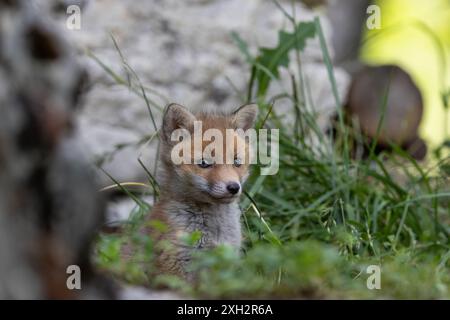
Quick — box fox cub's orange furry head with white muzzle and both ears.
[161,104,258,203]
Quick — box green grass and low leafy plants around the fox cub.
[95,4,450,299]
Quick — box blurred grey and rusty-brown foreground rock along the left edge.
[0,0,114,299]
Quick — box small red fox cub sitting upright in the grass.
[145,104,258,280]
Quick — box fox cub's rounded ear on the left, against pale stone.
[162,103,196,141]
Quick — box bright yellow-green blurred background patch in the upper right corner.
[361,0,450,148]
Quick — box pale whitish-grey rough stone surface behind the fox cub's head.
[34,0,348,185]
